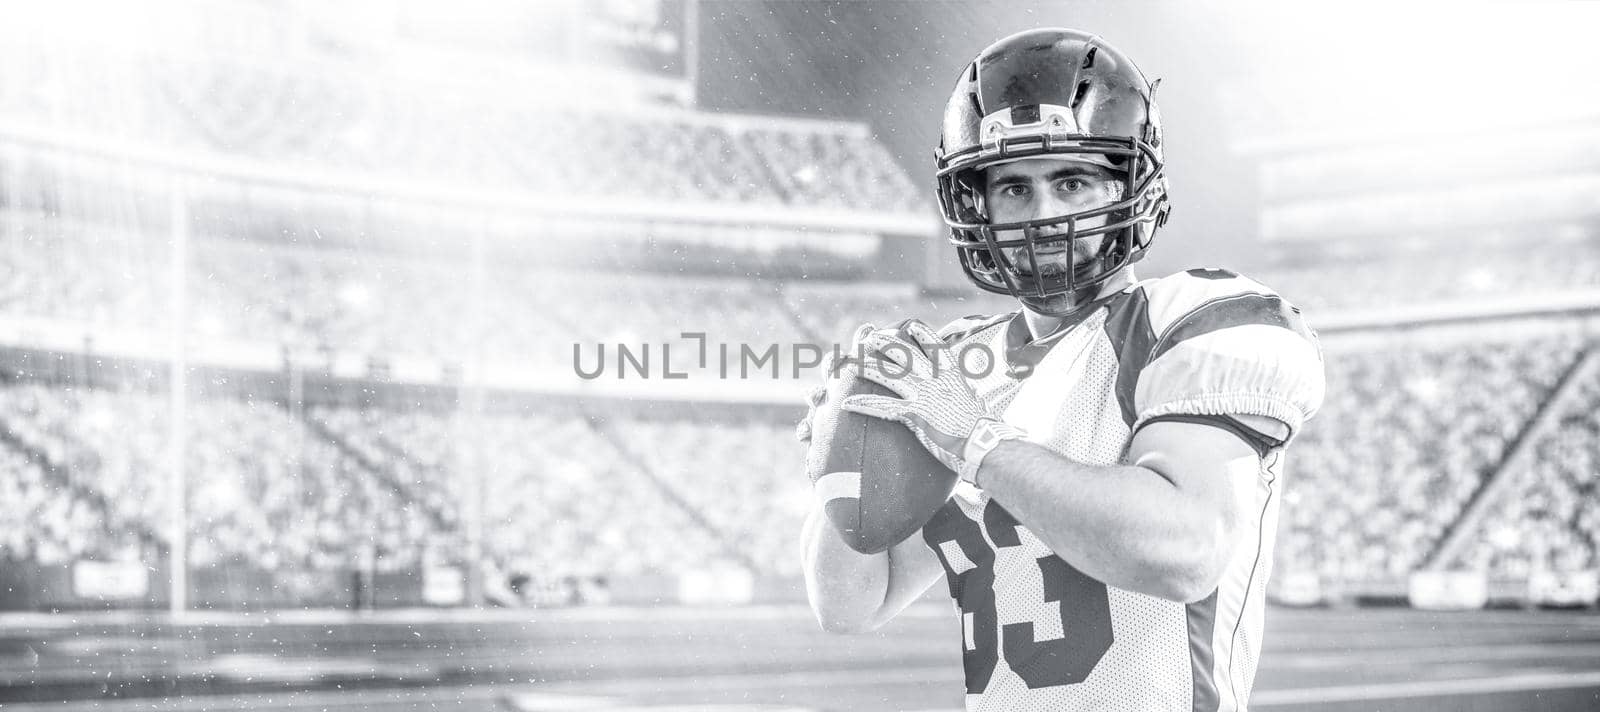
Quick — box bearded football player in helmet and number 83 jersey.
[800,29,1323,712]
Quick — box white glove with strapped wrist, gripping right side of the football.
[840,320,1024,485]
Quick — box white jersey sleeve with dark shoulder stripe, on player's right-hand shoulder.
[1133,270,1325,437]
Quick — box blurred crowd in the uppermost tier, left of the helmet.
[0,48,925,213]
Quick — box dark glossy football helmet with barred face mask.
[934,29,1171,314]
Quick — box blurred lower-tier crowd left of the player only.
[0,384,790,579]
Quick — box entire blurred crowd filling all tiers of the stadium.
[0,40,1600,590]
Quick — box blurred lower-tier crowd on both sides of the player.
[0,307,1600,582]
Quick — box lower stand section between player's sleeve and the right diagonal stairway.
[1277,336,1580,584]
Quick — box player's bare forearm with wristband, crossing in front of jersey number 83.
[979,440,1229,600]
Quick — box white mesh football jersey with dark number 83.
[922,269,1323,712]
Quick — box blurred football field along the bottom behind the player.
[0,605,1600,712]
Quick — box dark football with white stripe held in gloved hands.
[806,358,957,554]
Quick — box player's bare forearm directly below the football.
[800,507,890,632]
